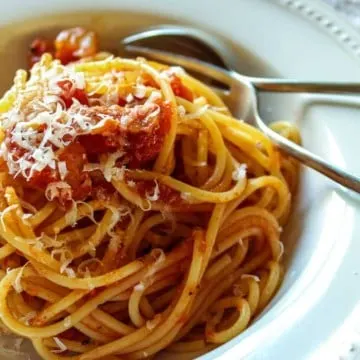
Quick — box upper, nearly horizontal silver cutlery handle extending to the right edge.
[248,77,360,94]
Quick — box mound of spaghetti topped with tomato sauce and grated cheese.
[0,27,300,360]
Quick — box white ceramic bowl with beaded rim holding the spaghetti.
[0,0,360,360]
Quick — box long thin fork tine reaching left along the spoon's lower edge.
[125,45,233,87]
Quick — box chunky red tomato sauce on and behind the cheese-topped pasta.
[16,27,190,205]
